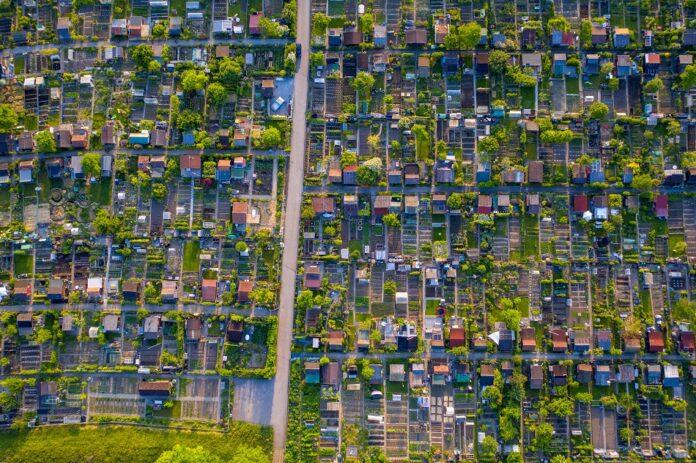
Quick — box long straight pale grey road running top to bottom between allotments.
[271,0,310,463]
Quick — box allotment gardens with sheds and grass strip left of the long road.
[0,0,298,463]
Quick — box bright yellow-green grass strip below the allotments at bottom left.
[0,423,273,463]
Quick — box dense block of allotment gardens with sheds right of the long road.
[286,0,696,463]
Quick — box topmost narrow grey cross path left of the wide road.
[2,38,289,56]
